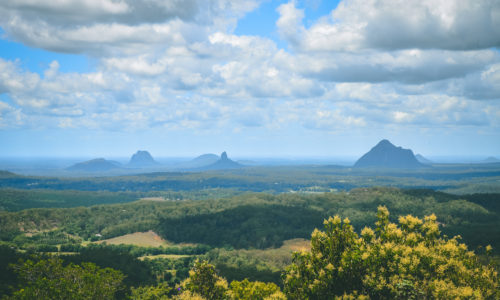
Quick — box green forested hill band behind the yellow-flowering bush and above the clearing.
[0,188,500,251]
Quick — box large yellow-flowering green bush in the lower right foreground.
[283,207,500,299]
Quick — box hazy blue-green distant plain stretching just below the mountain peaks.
[0,164,500,194]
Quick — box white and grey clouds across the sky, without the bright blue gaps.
[0,0,500,138]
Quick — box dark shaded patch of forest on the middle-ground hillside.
[159,205,323,249]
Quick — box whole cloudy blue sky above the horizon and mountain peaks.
[0,0,500,158]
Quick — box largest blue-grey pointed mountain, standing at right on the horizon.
[354,140,425,169]
